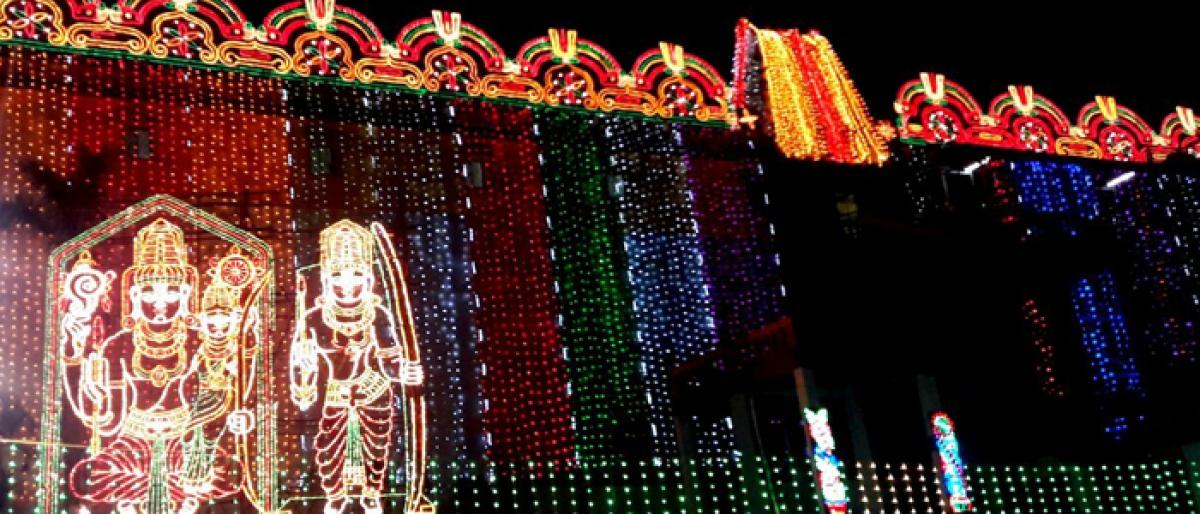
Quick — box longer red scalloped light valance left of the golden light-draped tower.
[0,0,732,122]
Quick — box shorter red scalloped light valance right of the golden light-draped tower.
[895,73,1200,162]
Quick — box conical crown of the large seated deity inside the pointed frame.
[126,217,196,286]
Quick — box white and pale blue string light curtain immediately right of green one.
[605,118,733,456]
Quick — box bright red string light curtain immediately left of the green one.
[452,101,575,465]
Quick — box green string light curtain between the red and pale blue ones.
[535,110,661,461]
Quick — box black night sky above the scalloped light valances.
[234,0,1180,124]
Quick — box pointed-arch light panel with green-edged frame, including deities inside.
[41,196,275,514]
